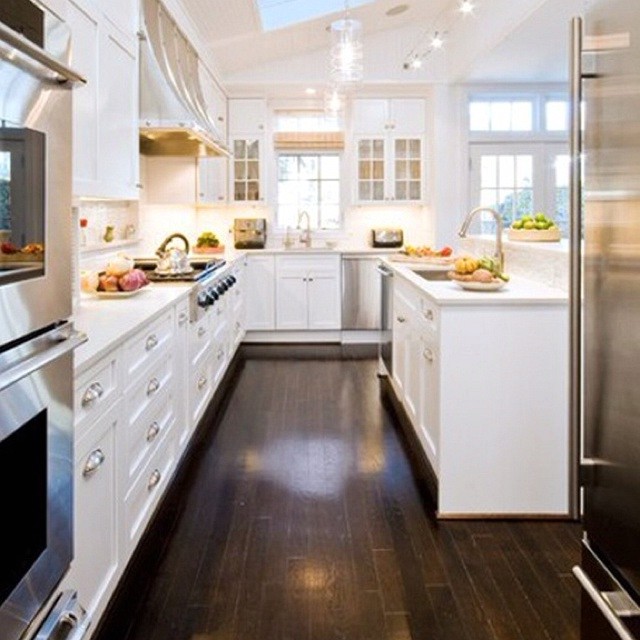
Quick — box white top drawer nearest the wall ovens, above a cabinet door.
[74,352,120,427]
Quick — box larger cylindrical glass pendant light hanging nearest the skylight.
[330,0,364,86]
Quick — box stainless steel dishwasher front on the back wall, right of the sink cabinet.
[342,254,382,331]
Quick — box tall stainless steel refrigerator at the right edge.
[572,0,640,640]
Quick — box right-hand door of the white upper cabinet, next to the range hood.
[96,30,139,198]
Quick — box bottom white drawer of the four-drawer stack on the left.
[124,437,176,554]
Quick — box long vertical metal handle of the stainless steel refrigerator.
[569,18,582,520]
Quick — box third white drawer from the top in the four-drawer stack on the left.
[125,393,175,481]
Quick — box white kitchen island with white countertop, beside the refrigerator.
[385,260,570,518]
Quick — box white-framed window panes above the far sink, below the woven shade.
[277,153,340,229]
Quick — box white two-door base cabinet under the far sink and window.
[276,255,341,330]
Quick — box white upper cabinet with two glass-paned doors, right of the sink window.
[352,98,427,204]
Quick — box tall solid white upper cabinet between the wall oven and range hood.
[66,0,139,199]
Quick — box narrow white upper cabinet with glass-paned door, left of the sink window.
[229,99,267,204]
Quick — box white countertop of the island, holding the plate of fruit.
[385,260,568,305]
